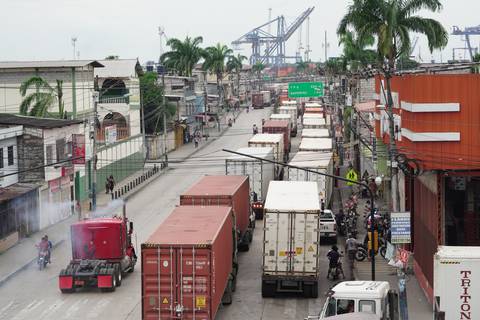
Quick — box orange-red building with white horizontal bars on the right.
[375,74,480,300]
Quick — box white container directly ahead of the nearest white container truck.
[287,151,333,206]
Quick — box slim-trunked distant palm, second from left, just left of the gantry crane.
[203,43,233,105]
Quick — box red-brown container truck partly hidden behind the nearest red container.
[180,176,255,251]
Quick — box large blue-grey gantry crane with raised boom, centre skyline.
[232,7,315,66]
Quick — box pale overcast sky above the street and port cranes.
[0,0,480,62]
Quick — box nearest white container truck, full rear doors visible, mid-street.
[262,181,320,298]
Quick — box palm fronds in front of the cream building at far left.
[20,76,67,118]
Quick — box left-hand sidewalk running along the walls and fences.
[0,113,239,286]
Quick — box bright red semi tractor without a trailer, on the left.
[58,207,137,293]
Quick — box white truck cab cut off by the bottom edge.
[309,281,398,320]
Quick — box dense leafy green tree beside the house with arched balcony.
[140,72,176,134]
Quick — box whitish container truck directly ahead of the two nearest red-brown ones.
[225,147,275,219]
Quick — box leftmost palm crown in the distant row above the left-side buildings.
[160,37,204,77]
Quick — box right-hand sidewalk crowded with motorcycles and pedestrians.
[333,166,433,320]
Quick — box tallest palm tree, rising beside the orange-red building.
[337,0,448,209]
